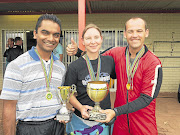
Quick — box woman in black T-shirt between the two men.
[65,24,116,135]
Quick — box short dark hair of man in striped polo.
[35,14,61,33]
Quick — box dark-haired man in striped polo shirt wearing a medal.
[0,14,66,135]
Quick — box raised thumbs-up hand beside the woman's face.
[66,38,78,56]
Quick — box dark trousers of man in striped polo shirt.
[16,119,65,135]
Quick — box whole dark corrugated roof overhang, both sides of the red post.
[0,0,180,15]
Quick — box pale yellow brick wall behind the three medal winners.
[0,13,180,92]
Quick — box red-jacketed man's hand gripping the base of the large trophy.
[96,109,116,123]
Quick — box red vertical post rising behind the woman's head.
[78,0,86,51]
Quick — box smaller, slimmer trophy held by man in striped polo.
[56,84,76,121]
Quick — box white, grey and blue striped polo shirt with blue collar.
[0,47,66,121]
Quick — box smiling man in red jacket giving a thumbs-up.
[66,17,162,135]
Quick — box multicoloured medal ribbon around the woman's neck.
[84,54,101,81]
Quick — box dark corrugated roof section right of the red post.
[90,1,180,13]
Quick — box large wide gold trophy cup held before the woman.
[87,81,109,120]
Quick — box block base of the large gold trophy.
[89,111,106,120]
